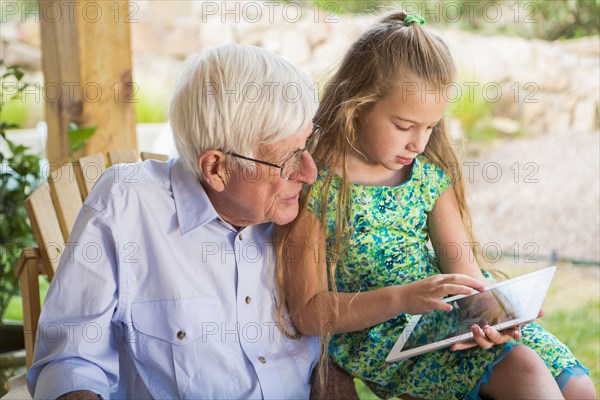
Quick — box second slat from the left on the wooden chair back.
[48,163,83,242]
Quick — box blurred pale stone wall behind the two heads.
[1,1,600,136]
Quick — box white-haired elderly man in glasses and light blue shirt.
[28,45,318,399]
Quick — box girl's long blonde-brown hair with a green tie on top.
[277,11,478,383]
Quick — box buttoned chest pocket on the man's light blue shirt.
[131,298,222,398]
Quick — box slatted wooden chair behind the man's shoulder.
[15,150,169,367]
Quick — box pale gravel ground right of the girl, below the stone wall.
[463,132,600,266]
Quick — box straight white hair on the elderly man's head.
[169,44,318,179]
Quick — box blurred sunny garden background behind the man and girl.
[0,0,600,398]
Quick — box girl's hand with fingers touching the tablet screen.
[396,274,485,314]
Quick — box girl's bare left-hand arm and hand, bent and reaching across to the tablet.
[282,211,484,335]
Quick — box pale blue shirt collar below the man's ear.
[171,158,219,235]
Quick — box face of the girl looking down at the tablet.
[354,80,448,172]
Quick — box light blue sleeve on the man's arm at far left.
[27,205,119,399]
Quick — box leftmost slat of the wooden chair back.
[25,182,64,279]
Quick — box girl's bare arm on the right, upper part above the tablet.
[428,186,485,282]
